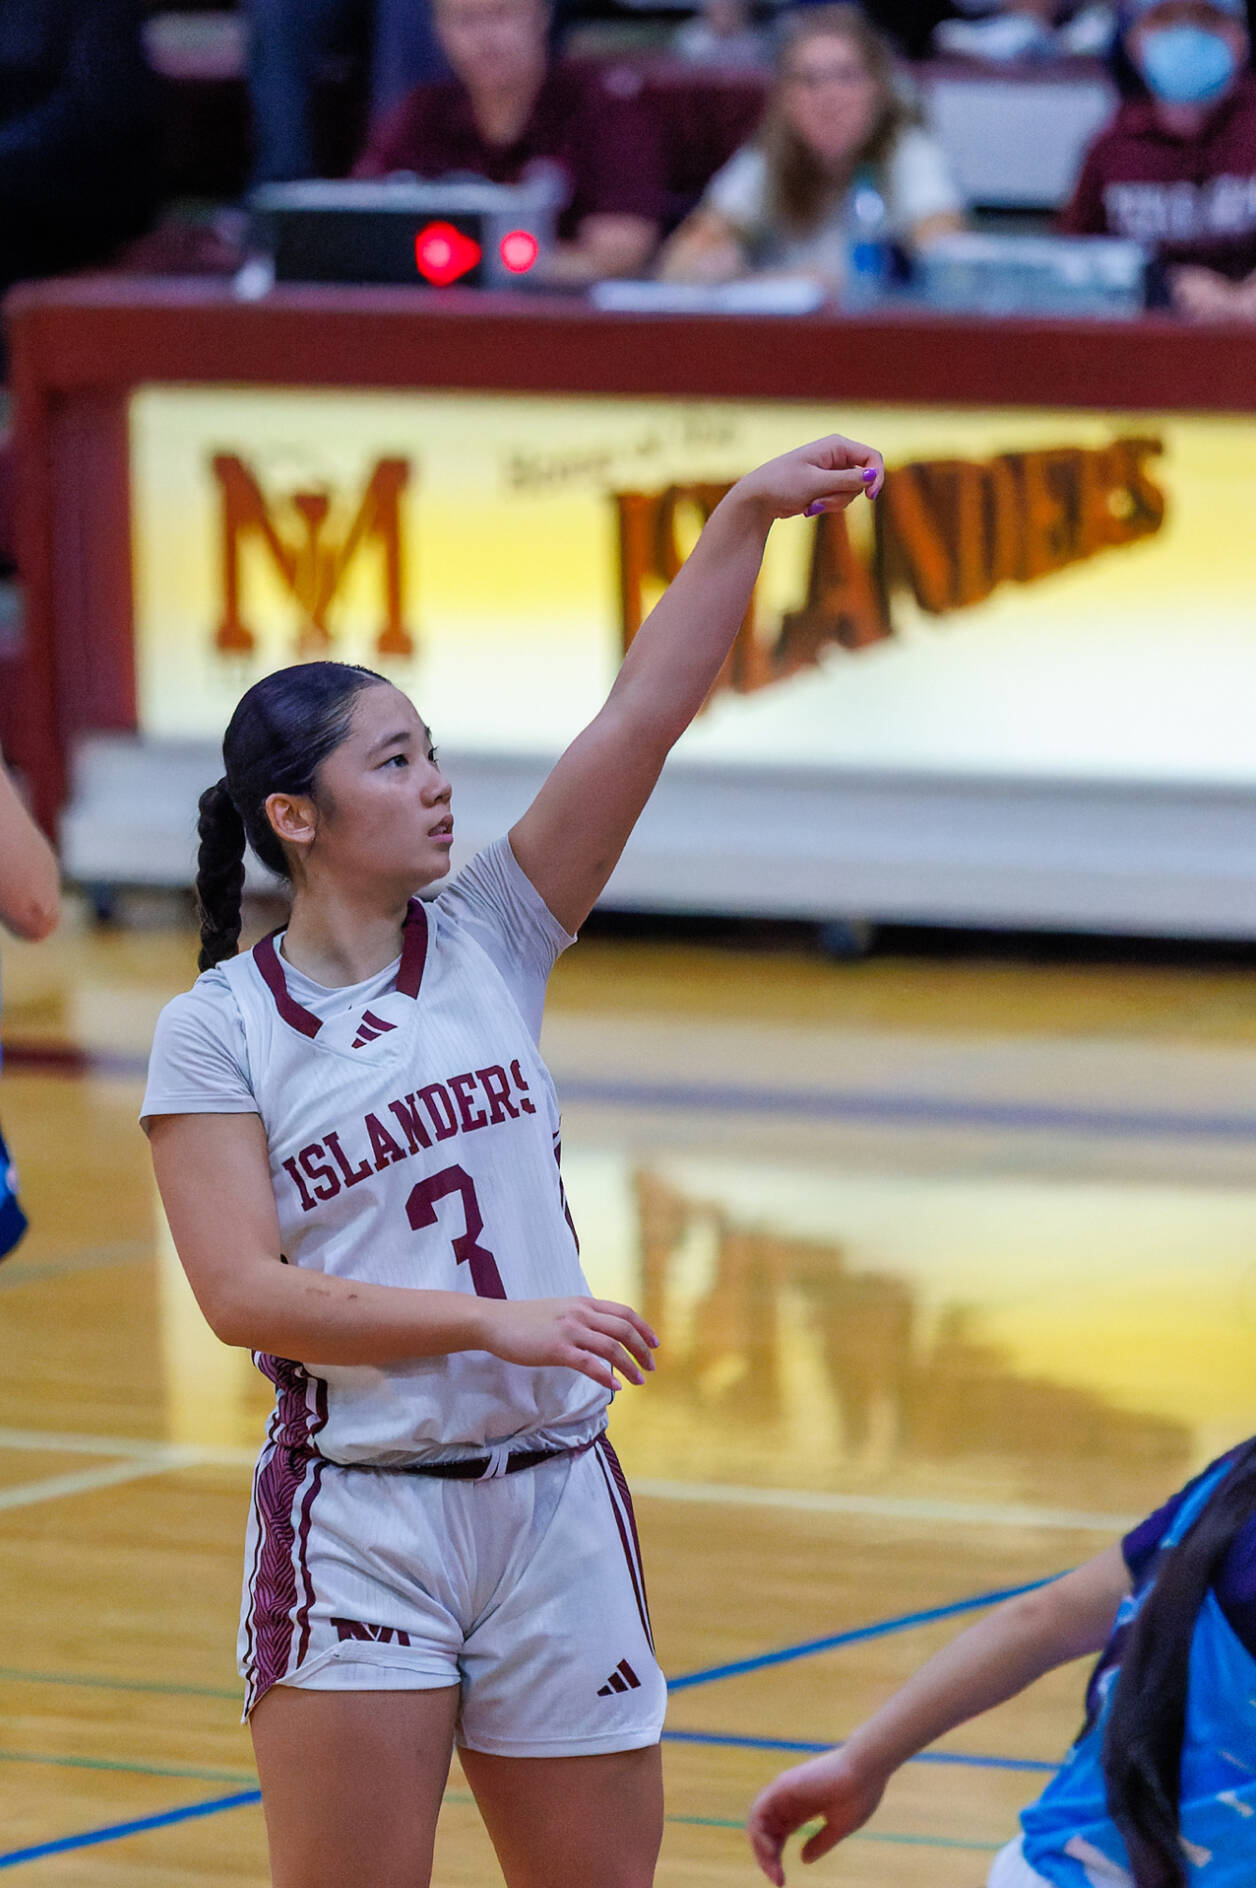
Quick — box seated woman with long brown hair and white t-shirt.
[661,6,963,291]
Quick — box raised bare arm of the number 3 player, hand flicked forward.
[510,434,884,931]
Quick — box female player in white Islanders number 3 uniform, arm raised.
[144,438,882,1888]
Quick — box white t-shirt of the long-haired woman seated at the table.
[703,125,963,281]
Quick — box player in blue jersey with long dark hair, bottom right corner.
[750,1437,1256,1888]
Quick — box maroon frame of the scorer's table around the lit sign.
[6,276,1256,829]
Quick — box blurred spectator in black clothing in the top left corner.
[0,0,155,302]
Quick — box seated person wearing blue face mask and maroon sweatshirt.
[1060,0,1256,321]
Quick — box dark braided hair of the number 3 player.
[196,663,385,970]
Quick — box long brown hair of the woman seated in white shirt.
[759,6,916,234]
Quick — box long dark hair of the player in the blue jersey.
[1103,1439,1256,1888]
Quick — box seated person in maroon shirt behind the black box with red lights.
[355,0,663,285]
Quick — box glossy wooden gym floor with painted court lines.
[0,902,1256,1888]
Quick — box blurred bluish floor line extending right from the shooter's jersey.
[559,1080,1256,1140]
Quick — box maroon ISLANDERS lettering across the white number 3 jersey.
[283,1061,536,1212]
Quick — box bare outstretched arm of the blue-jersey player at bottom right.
[748,1546,1129,1888]
